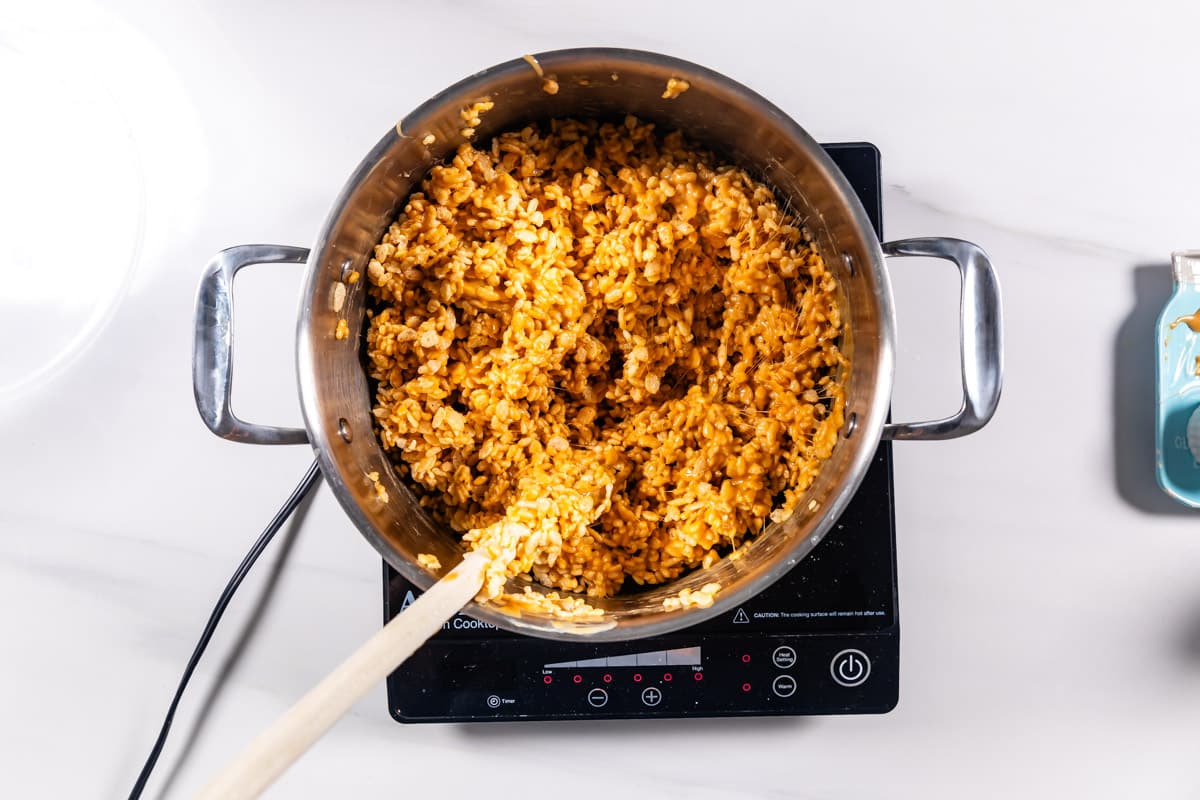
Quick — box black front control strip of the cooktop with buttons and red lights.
[389,633,899,722]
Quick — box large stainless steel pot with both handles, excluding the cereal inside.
[193,49,1002,640]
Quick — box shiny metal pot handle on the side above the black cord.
[192,245,308,445]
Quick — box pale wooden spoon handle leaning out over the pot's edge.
[196,552,487,800]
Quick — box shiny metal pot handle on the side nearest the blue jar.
[882,237,1004,440]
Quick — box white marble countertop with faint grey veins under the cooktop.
[0,0,1200,800]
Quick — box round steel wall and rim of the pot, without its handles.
[299,50,892,638]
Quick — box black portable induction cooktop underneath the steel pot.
[384,144,900,722]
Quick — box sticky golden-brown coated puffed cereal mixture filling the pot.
[366,118,848,606]
